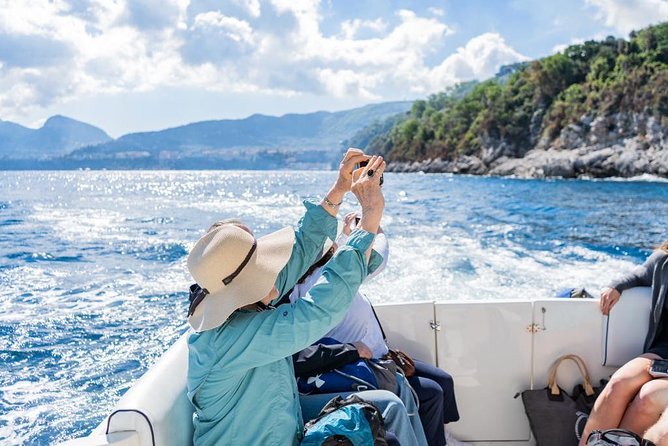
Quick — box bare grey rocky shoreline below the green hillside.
[389,113,668,178]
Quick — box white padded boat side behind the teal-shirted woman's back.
[104,333,194,446]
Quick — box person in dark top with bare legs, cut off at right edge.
[580,241,668,445]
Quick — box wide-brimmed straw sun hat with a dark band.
[188,224,295,332]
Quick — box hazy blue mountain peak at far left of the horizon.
[0,116,111,159]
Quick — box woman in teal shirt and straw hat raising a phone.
[187,149,385,446]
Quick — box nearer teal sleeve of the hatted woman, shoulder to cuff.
[212,230,374,373]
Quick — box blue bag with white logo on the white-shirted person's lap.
[297,338,378,395]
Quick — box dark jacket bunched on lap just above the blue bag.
[292,343,360,377]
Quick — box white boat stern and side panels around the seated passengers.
[62,287,651,446]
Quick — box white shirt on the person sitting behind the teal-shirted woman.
[290,233,389,358]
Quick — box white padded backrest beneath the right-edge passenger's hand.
[601,287,652,367]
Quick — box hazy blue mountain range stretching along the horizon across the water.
[0,101,412,169]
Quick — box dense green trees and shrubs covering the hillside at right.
[368,23,668,161]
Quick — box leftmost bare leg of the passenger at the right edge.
[580,353,658,446]
